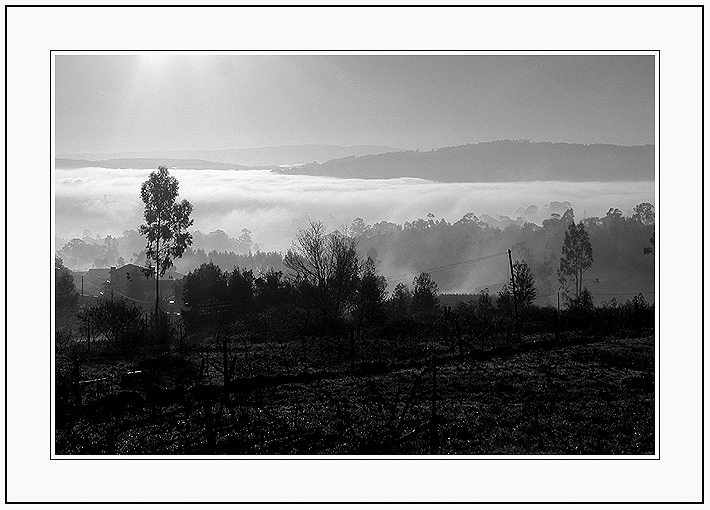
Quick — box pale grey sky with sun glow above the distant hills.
[54,53,655,156]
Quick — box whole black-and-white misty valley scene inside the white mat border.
[54,52,657,455]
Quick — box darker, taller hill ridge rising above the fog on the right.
[280,140,655,182]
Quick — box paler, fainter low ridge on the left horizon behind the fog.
[59,144,401,168]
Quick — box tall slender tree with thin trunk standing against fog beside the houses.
[138,166,193,315]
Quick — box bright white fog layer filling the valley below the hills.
[55,168,655,251]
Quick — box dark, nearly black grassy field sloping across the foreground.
[56,337,655,455]
